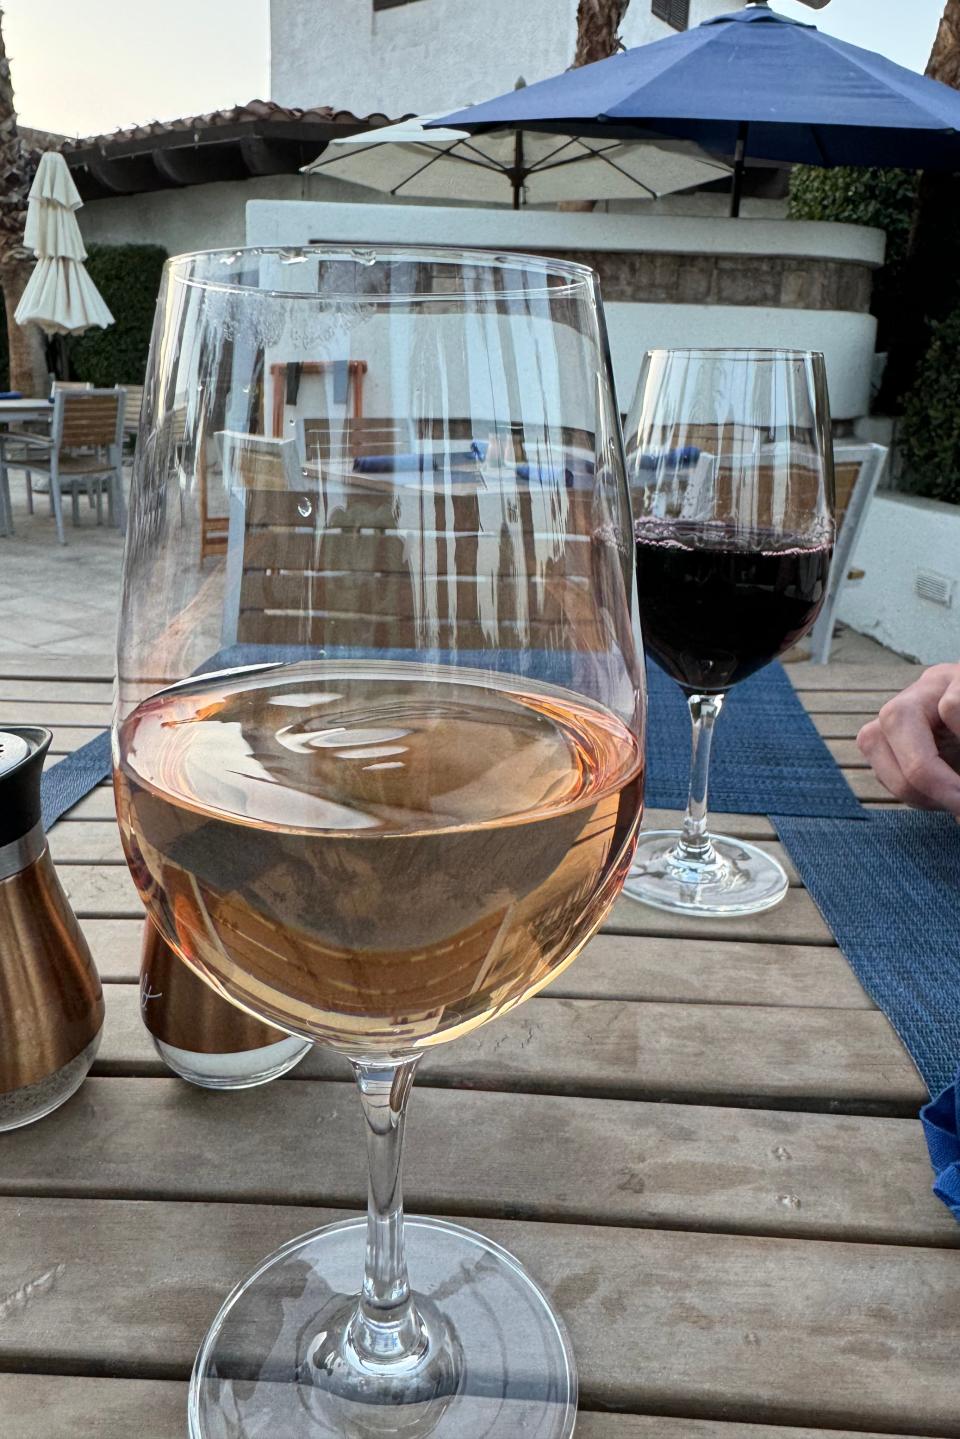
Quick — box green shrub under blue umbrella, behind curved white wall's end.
[789,165,920,350]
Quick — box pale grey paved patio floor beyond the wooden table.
[0,471,897,665]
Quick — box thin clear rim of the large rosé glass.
[164,242,596,305]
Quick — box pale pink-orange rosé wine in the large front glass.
[115,662,642,1055]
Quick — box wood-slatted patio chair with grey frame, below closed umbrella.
[0,387,125,544]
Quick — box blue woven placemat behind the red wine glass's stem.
[646,662,866,820]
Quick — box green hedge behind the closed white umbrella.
[66,245,167,386]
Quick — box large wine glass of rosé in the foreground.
[114,246,643,1439]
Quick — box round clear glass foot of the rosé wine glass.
[189,1219,577,1439]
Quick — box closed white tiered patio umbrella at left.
[13,150,114,335]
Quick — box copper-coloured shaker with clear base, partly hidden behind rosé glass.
[140,920,312,1089]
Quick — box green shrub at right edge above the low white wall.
[900,308,960,505]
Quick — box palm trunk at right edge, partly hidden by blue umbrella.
[879,0,960,412]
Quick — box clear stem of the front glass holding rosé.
[350,1055,426,1366]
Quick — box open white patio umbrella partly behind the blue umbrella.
[304,115,731,210]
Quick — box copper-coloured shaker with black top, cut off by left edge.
[0,727,104,1131]
